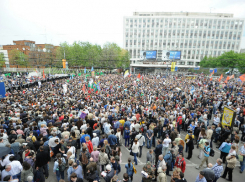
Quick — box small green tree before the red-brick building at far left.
[9,49,29,68]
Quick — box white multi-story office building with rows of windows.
[123,12,244,71]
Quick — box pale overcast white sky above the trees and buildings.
[0,0,245,48]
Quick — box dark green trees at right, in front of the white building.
[200,51,245,73]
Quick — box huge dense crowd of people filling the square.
[0,75,245,182]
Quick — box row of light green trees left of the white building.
[57,41,130,68]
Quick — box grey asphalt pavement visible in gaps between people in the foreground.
[46,131,245,182]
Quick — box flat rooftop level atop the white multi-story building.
[133,12,233,18]
